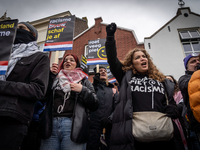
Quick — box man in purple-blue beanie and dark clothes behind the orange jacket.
[178,53,200,150]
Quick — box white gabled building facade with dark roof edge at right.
[144,7,200,80]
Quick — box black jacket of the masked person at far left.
[0,52,50,125]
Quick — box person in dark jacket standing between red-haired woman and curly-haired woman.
[87,66,118,150]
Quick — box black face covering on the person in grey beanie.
[14,29,36,44]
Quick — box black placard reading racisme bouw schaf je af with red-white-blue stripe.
[44,16,75,51]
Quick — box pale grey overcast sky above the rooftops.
[0,0,200,42]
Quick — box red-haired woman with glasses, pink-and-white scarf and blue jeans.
[40,54,99,150]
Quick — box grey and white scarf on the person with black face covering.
[0,41,40,81]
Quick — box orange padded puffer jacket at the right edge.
[188,70,200,122]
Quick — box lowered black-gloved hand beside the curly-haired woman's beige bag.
[164,105,179,119]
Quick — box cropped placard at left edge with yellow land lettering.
[0,19,18,75]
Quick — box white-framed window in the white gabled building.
[179,30,200,56]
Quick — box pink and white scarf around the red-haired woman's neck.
[58,68,86,93]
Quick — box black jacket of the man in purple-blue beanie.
[178,71,200,133]
